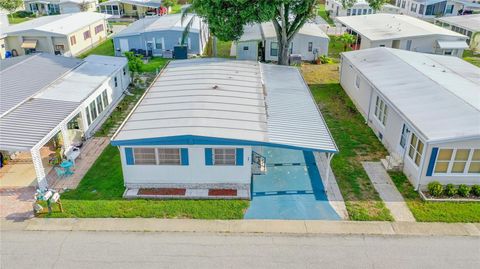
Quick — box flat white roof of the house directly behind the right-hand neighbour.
[336,14,468,41]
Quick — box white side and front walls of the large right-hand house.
[340,58,480,188]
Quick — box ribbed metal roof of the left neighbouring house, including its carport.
[0,54,127,150]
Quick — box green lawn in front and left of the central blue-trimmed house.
[41,146,249,219]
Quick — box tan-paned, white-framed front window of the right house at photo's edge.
[434,148,480,174]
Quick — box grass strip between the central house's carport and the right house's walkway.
[302,64,393,221]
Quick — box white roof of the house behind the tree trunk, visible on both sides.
[239,22,329,41]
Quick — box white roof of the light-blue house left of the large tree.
[115,14,200,37]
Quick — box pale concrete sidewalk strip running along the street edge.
[0,218,480,237]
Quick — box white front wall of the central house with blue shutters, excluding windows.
[119,145,252,187]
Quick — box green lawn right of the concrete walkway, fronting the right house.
[389,172,480,222]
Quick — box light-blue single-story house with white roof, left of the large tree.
[113,14,209,56]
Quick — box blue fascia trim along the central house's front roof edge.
[110,135,338,153]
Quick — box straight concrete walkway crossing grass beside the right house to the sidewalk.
[362,162,415,221]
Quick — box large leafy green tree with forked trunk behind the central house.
[190,0,317,65]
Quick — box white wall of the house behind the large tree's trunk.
[265,33,330,61]
